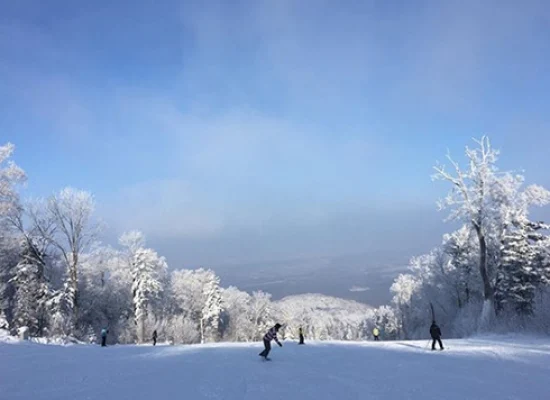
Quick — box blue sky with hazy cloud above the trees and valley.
[0,0,550,266]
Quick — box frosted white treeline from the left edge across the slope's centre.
[0,145,396,343]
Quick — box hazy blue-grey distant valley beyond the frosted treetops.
[214,252,409,306]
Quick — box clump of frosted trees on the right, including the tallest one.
[392,138,550,338]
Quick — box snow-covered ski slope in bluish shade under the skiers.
[0,337,550,400]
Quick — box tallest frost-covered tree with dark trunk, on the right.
[434,137,550,327]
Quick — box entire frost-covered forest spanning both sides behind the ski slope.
[0,137,550,344]
